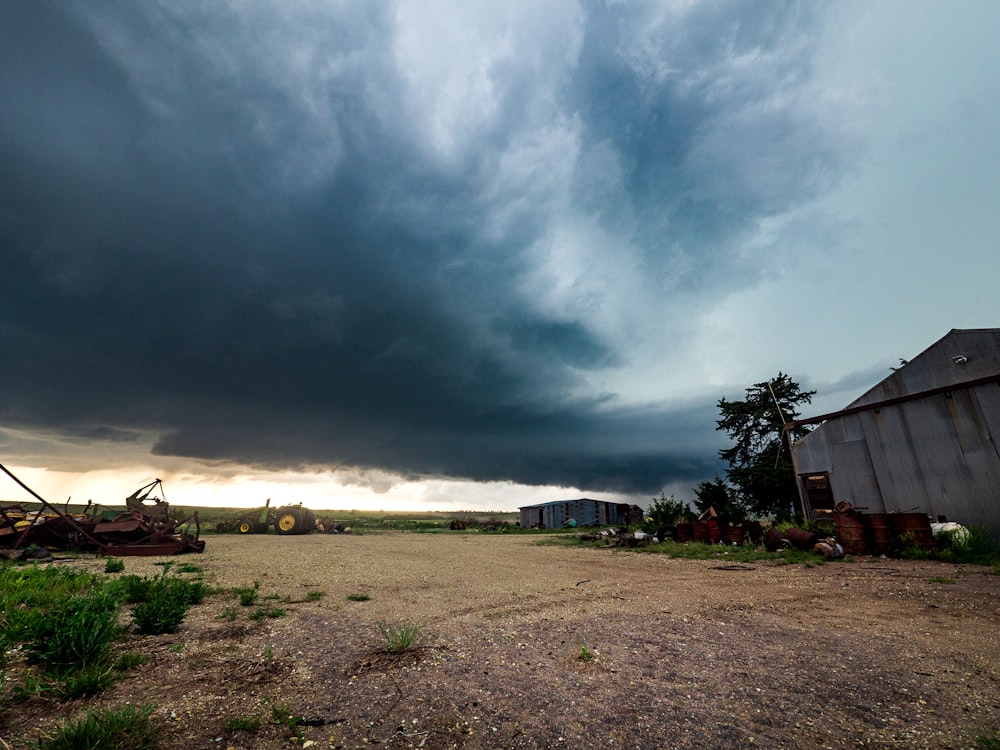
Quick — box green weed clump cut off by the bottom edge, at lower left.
[38,706,160,750]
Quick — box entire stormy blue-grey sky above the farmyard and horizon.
[0,0,1000,507]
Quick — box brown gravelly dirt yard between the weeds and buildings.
[0,533,1000,750]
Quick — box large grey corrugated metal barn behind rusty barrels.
[786,328,1000,534]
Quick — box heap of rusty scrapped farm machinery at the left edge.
[0,464,205,557]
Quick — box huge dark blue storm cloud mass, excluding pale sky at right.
[0,2,852,492]
